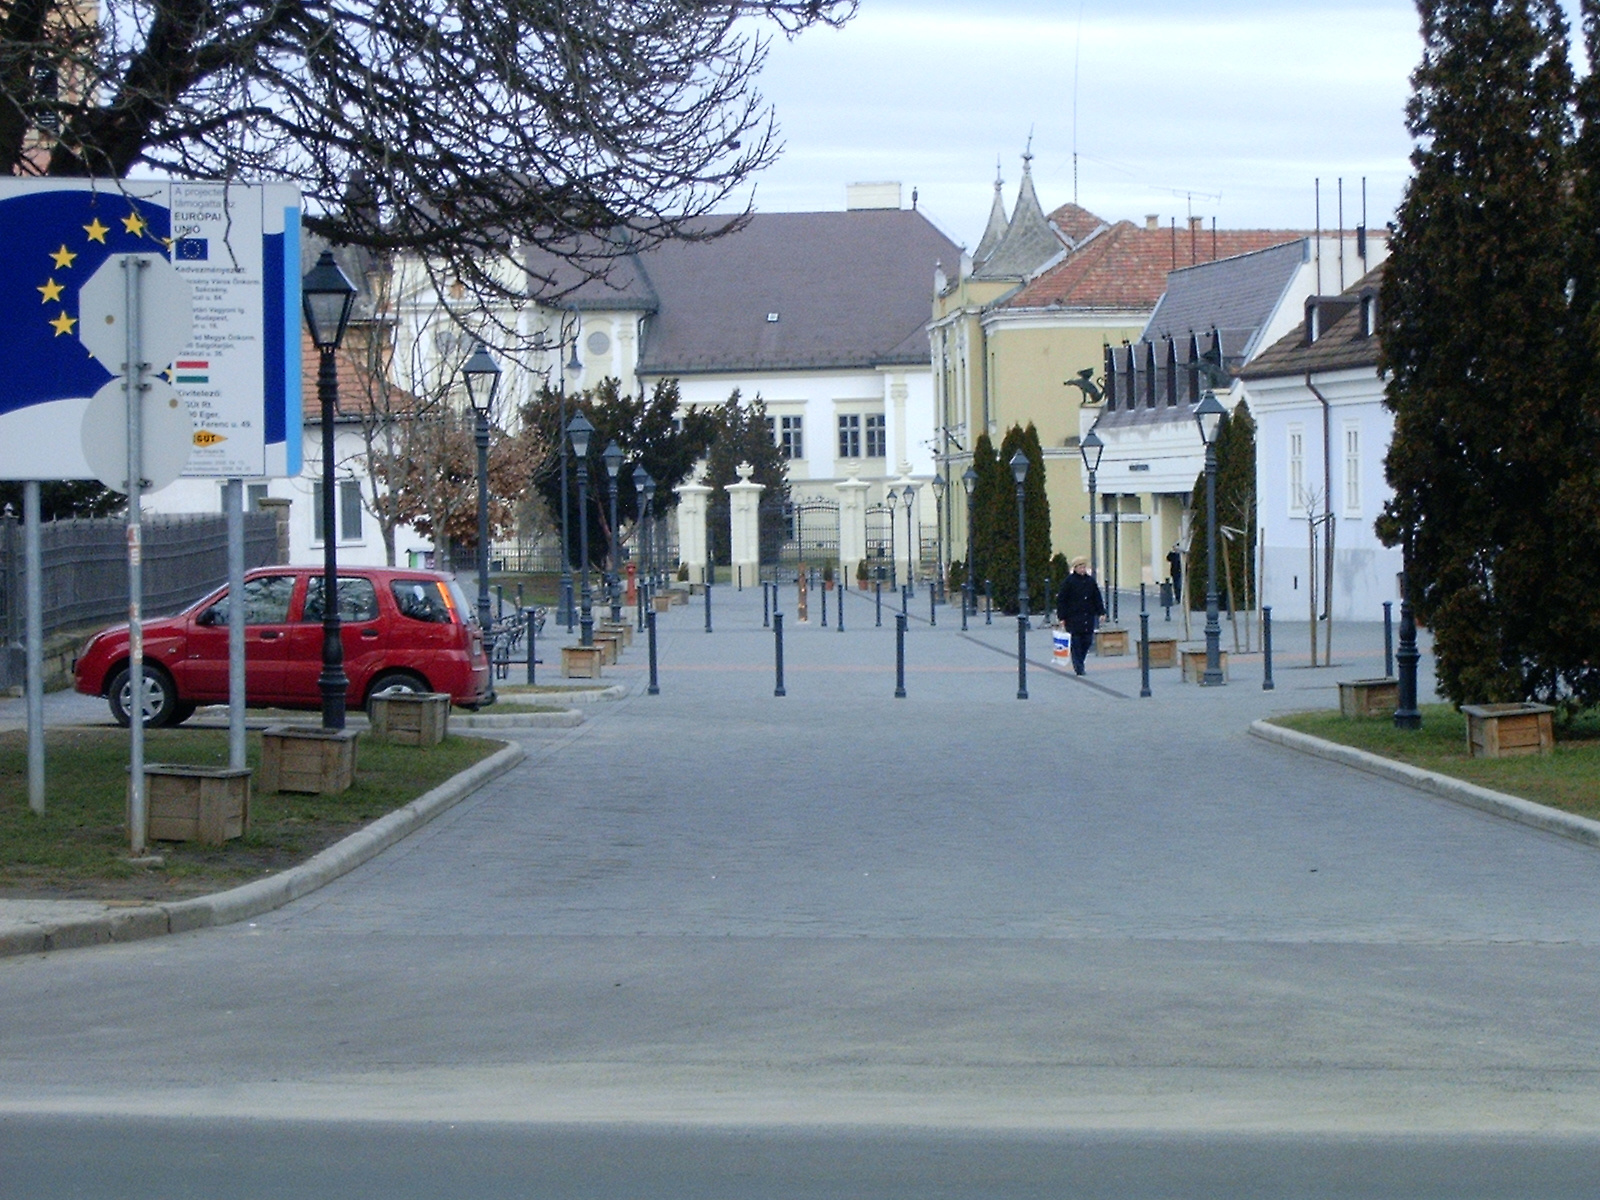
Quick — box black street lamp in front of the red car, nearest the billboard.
[301,250,355,730]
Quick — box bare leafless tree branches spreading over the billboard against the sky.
[0,0,854,310]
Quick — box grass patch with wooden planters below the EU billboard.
[0,728,501,901]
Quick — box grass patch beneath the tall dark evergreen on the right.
[1272,704,1600,819]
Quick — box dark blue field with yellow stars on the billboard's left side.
[0,187,172,413]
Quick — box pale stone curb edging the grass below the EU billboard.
[0,744,528,957]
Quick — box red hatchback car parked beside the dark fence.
[75,566,491,725]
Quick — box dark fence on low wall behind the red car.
[0,512,283,688]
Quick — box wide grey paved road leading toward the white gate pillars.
[0,589,1600,1195]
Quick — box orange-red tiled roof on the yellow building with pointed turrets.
[1000,222,1301,310]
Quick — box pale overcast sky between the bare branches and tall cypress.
[742,0,1446,246]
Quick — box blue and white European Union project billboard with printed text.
[0,179,301,480]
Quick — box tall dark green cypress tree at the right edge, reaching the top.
[1378,0,1600,702]
